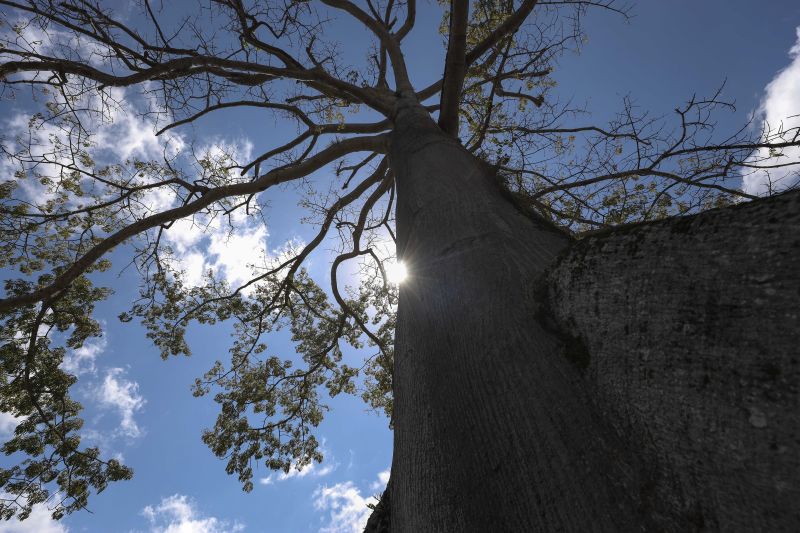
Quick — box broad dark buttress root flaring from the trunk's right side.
[544,192,800,532]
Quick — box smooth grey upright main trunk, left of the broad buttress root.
[390,101,672,533]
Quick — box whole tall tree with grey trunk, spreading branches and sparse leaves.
[0,0,800,531]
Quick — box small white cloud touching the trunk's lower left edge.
[314,470,389,533]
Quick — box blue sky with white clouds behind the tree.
[0,0,800,533]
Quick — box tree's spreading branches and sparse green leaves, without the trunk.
[0,0,800,518]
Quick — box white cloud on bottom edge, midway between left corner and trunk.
[142,494,244,533]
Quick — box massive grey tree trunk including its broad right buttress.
[376,103,798,533]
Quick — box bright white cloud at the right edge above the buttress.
[742,27,800,194]
